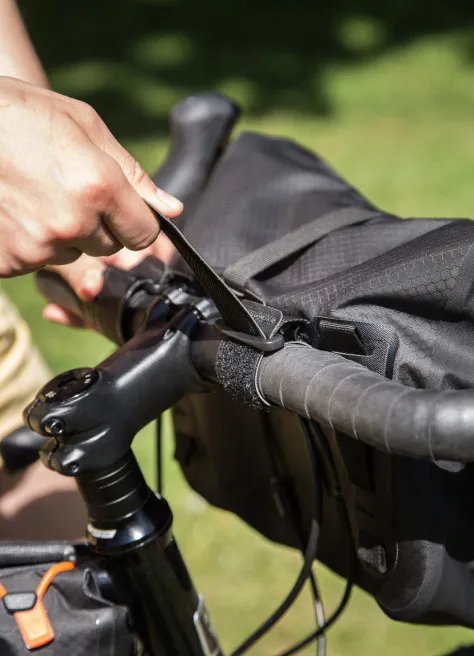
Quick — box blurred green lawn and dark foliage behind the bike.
[5,0,474,656]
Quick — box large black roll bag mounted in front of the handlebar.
[168,133,474,627]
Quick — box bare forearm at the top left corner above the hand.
[0,0,48,86]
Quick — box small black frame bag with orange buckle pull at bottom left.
[0,542,138,656]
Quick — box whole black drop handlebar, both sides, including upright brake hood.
[26,95,474,468]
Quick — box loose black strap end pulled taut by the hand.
[145,201,265,337]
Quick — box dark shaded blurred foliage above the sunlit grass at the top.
[20,0,474,132]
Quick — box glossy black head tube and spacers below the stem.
[77,451,222,656]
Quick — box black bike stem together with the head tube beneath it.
[25,307,222,656]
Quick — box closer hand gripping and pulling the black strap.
[0,77,182,277]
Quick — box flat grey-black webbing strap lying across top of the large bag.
[224,207,383,290]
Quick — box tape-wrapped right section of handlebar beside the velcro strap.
[257,343,474,462]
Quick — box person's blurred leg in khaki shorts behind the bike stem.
[0,288,87,542]
